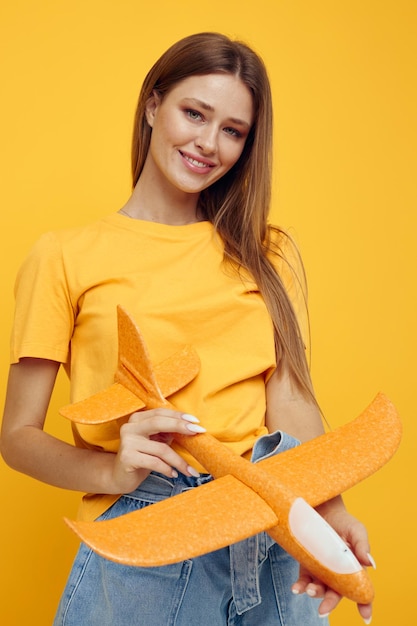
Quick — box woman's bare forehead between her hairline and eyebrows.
[166,73,254,125]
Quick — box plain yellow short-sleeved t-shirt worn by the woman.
[11,213,302,519]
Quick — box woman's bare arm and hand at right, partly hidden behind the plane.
[266,368,372,623]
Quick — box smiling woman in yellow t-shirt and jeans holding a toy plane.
[2,33,371,626]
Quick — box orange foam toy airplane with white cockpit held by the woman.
[61,307,401,604]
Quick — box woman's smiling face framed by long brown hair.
[143,74,254,197]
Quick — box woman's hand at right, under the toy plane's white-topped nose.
[292,498,375,624]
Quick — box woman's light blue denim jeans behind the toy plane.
[54,433,328,626]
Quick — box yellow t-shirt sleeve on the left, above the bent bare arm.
[11,233,74,363]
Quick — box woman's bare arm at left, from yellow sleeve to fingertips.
[1,358,203,494]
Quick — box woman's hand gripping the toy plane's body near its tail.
[111,408,205,493]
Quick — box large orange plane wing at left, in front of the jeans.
[65,475,278,567]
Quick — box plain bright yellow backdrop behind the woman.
[0,0,417,626]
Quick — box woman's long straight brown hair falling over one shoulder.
[132,33,314,399]
